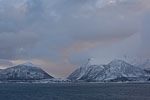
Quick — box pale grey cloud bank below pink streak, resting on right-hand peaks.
[70,33,141,65]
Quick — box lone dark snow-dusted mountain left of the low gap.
[0,62,53,80]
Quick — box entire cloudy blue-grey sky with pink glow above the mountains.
[0,0,150,77]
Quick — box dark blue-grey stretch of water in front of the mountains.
[0,83,150,100]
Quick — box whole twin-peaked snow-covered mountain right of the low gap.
[68,60,149,81]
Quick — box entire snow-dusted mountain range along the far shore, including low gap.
[0,59,150,83]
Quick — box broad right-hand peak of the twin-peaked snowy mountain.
[96,60,148,81]
